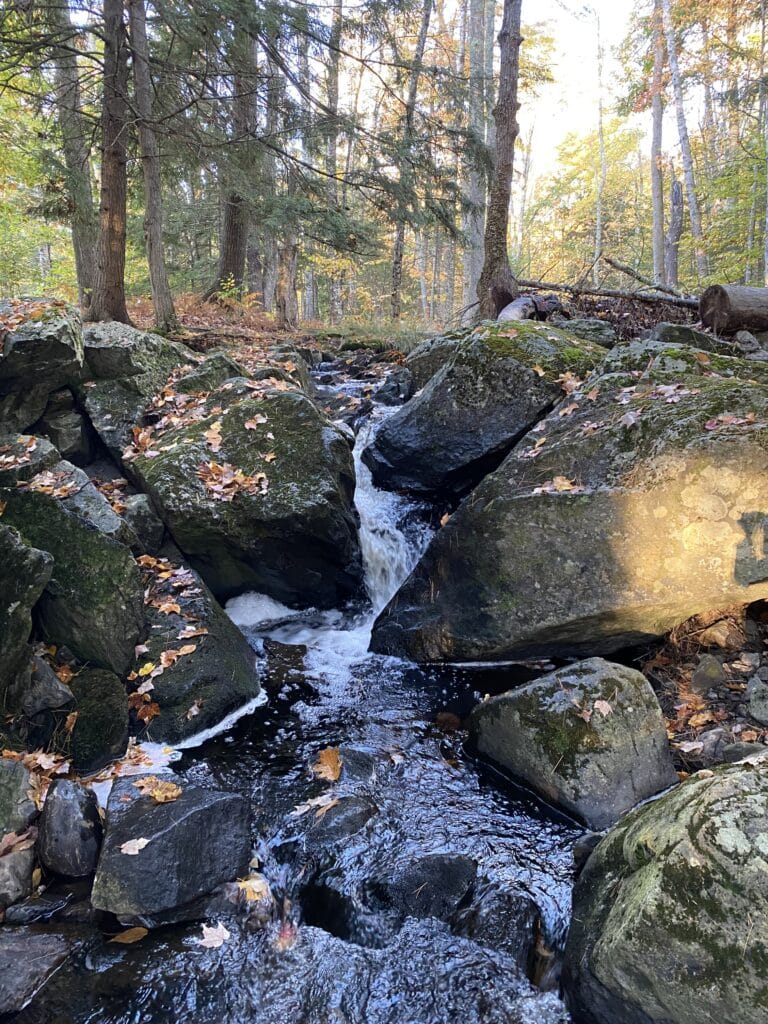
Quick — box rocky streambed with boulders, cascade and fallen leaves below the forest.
[0,302,768,1024]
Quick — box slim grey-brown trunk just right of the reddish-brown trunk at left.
[127,0,178,331]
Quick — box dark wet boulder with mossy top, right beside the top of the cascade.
[362,321,605,496]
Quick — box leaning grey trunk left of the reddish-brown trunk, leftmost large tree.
[46,3,98,316]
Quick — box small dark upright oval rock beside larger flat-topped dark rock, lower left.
[37,779,101,878]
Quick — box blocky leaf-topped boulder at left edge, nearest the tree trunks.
[0,299,83,432]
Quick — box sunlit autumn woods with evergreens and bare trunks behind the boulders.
[0,0,768,330]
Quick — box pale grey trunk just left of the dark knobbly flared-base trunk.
[462,0,494,315]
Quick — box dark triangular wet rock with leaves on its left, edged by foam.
[137,551,261,743]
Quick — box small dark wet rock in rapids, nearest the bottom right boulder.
[453,886,540,975]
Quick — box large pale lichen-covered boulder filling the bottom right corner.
[563,759,768,1024]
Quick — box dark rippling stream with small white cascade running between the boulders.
[16,372,583,1024]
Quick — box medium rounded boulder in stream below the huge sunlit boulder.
[470,658,677,830]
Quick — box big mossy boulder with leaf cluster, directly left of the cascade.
[131,378,361,607]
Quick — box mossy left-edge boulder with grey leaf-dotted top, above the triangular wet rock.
[0,462,144,674]
